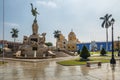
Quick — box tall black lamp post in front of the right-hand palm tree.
[110,18,116,69]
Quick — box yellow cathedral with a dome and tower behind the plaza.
[56,30,80,51]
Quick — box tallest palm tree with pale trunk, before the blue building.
[100,14,112,51]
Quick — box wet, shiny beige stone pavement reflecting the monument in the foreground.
[0,58,120,80]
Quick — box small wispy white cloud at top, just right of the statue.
[36,1,57,8]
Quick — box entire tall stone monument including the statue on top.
[18,3,55,58]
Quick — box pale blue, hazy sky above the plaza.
[0,0,120,44]
